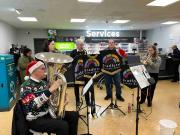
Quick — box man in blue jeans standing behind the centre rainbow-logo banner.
[104,39,124,102]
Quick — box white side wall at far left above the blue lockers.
[0,21,17,53]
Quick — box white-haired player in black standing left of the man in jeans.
[70,39,89,106]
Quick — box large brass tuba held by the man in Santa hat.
[35,52,73,118]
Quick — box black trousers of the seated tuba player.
[27,111,78,135]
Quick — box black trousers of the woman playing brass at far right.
[140,73,158,103]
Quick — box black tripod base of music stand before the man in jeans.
[100,83,126,115]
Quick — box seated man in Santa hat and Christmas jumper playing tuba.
[21,61,78,135]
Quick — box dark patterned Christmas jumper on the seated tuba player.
[20,77,51,121]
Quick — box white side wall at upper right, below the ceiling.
[146,24,180,49]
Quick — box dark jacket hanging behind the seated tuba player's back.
[11,101,29,135]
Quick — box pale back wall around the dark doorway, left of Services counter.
[17,29,48,54]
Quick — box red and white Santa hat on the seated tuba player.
[24,61,44,80]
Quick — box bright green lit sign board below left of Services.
[55,42,76,51]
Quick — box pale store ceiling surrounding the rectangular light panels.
[0,0,180,30]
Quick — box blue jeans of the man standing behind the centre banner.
[104,73,121,97]
